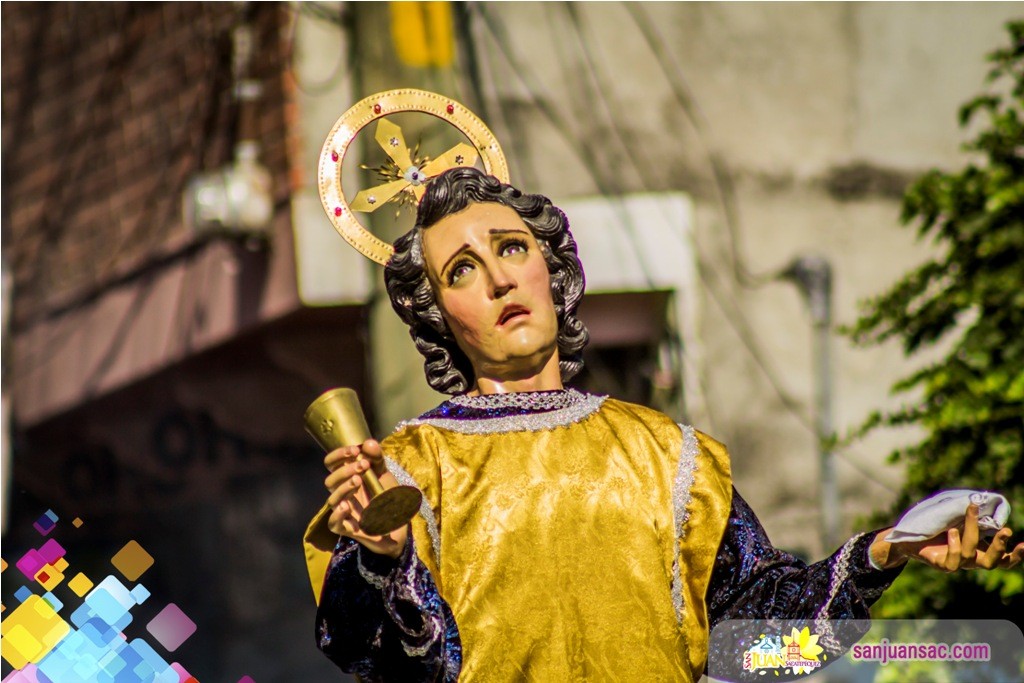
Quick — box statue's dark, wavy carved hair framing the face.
[384,167,590,394]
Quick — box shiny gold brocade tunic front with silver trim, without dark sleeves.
[299,391,731,682]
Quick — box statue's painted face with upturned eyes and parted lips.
[423,202,558,380]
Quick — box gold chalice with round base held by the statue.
[302,388,423,536]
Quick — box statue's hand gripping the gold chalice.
[324,438,409,558]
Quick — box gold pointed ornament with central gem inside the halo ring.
[350,119,477,213]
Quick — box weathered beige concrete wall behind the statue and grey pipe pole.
[323,3,1024,555]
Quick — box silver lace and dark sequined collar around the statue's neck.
[397,389,605,434]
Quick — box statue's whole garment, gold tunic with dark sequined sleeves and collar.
[304,390,900,683]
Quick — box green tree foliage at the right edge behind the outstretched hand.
[847,22,1024,624]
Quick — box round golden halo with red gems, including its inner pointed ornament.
[316,88,509,265]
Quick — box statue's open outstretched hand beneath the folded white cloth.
[870,505,1024,571]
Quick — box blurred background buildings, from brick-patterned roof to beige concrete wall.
[2,2,1024,683]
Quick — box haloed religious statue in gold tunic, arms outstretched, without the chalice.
[306,90,1024,683]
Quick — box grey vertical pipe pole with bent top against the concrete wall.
[781,256,841,552]
